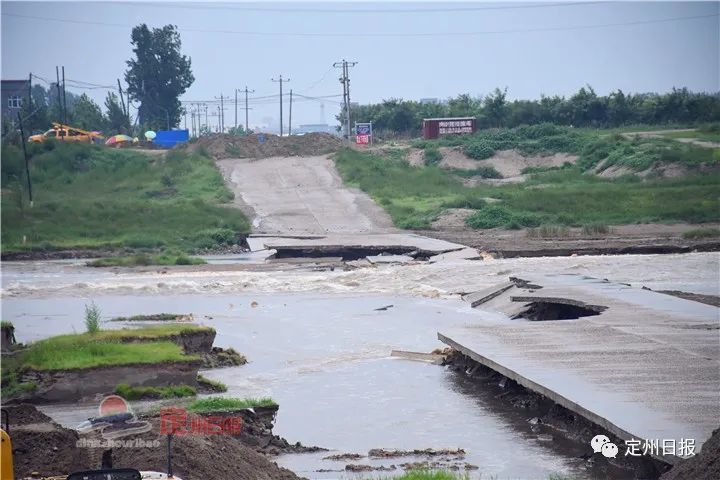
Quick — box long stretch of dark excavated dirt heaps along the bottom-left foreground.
[3,404,299,480]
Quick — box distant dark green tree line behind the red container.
[338,86,720,136]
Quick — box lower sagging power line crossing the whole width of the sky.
[2,12,720,38]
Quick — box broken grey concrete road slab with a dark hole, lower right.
[438,275,720,464]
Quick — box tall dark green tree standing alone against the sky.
[125,23,195,129]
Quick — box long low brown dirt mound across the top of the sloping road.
[185,133,342,160]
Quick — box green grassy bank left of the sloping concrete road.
[2,142,249,255]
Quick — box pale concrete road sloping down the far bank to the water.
[217,156,398,235]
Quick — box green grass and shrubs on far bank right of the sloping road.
[335,147,720,229]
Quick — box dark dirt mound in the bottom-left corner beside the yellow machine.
[3,404,90,478]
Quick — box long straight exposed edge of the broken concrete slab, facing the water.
[437,332,679,465]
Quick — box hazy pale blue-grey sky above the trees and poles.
[1,1,720,126]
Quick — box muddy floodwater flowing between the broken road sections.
[2,253,718,479]
